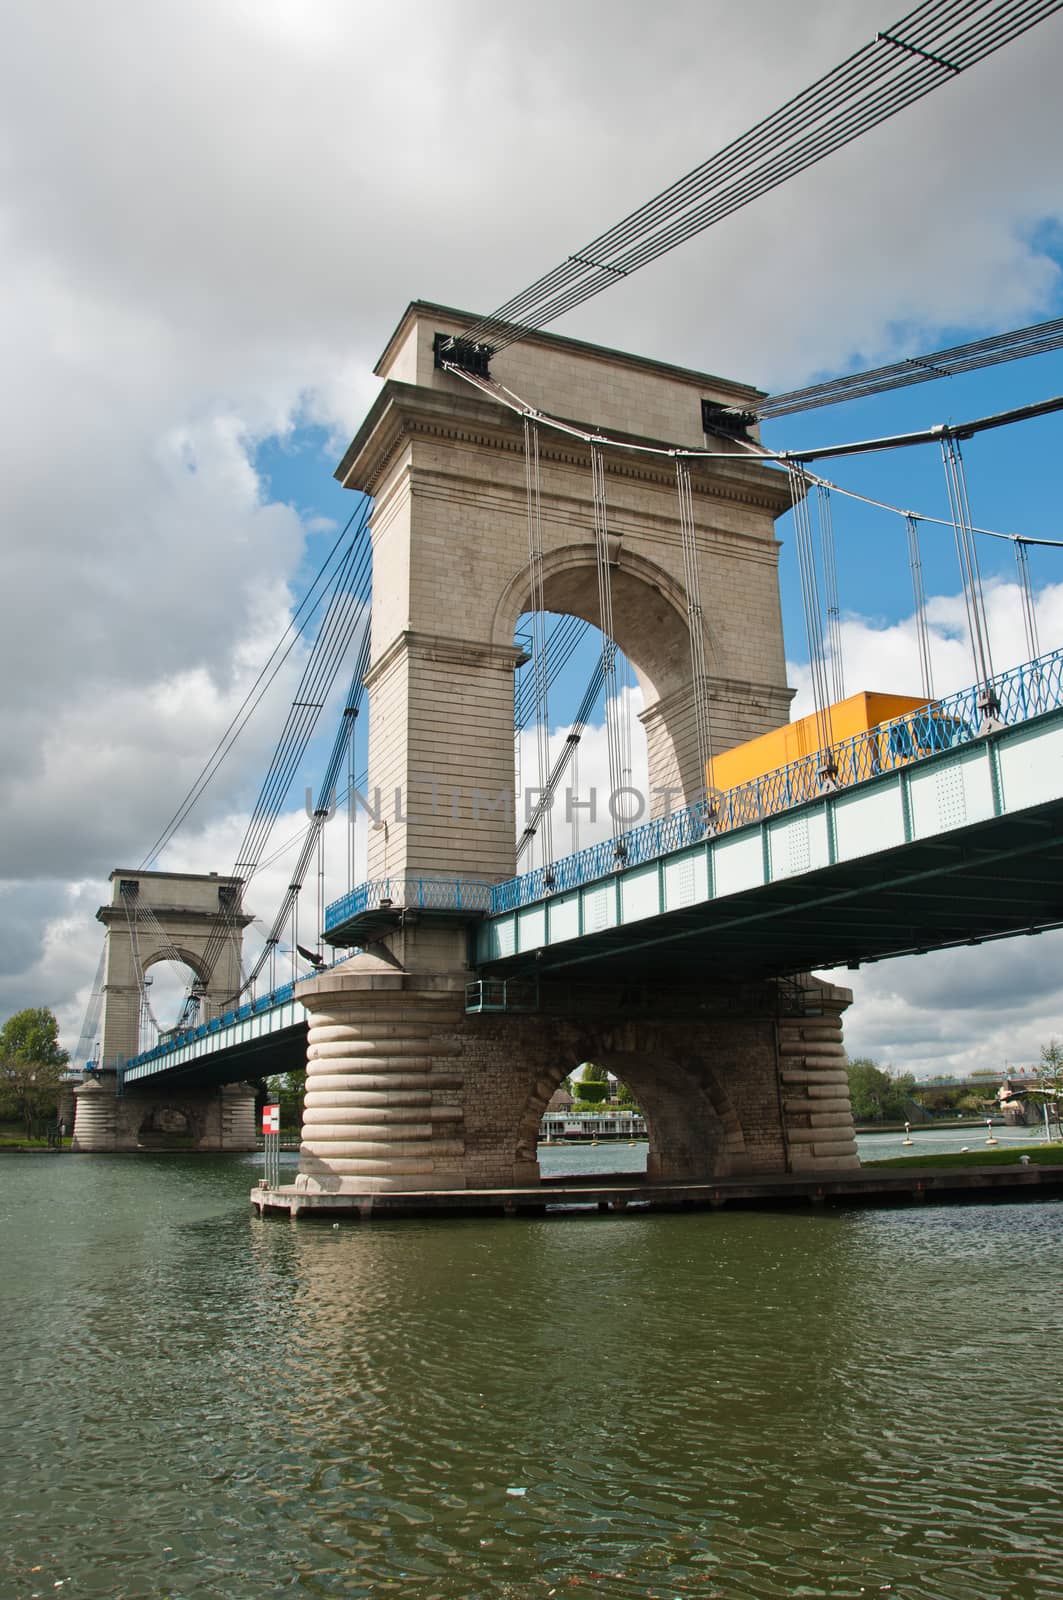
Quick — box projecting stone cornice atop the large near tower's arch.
[335,381,791,517]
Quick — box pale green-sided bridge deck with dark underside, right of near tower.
[477,710,1063,978]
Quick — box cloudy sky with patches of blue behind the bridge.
[0,0,1063,1070]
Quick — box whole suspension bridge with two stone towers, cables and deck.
[64,0,1063,1210]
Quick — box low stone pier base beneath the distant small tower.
[70,1072,258,1152]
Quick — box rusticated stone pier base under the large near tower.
[288,954,860,1197]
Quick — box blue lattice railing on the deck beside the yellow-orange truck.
[490,650,1063,915]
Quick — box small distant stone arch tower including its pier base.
[74,869,255,1150]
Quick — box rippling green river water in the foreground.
[0,1152,1063,1600]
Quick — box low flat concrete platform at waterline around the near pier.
[251,1162,1063,1221]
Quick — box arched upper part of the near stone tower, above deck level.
[336,304,792,878]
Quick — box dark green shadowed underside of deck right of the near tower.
[480,800,1063,979]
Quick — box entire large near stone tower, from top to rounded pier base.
[288,302,855,1192]
